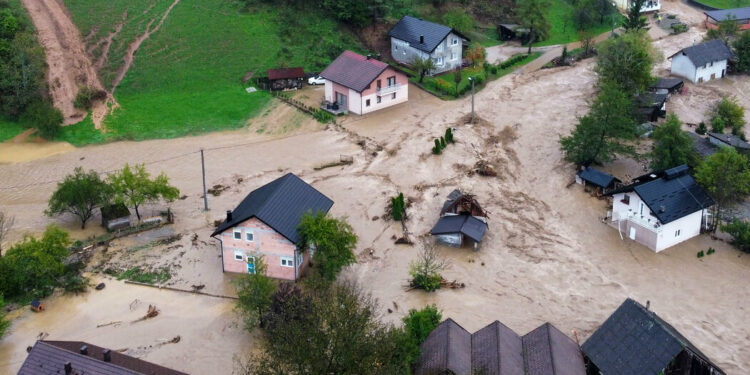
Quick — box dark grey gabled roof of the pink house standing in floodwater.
[211,173,333,243]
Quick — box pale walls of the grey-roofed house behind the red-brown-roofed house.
[391,32,464,74]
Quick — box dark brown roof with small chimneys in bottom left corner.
[18,340,187,375]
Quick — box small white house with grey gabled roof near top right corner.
[669,39,733,83]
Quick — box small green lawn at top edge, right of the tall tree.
[534,0,624,46]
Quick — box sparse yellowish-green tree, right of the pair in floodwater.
[109,164,180,220]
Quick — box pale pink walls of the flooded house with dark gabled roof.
[217,217,310,280]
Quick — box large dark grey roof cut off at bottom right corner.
[581,298,724,375]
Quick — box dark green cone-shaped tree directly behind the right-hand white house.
[651,113,696,170]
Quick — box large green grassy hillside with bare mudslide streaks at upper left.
[65,0,361,144]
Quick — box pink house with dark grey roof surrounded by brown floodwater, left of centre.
[211,173,333,280]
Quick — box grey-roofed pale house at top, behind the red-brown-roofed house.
[388,16,469,74]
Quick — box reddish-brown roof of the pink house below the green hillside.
[320,51,388,92]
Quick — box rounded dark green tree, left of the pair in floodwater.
[45,167,110,229]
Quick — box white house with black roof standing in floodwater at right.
[610,165,714,253]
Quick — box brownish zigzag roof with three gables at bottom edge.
[415,318,586,375]
